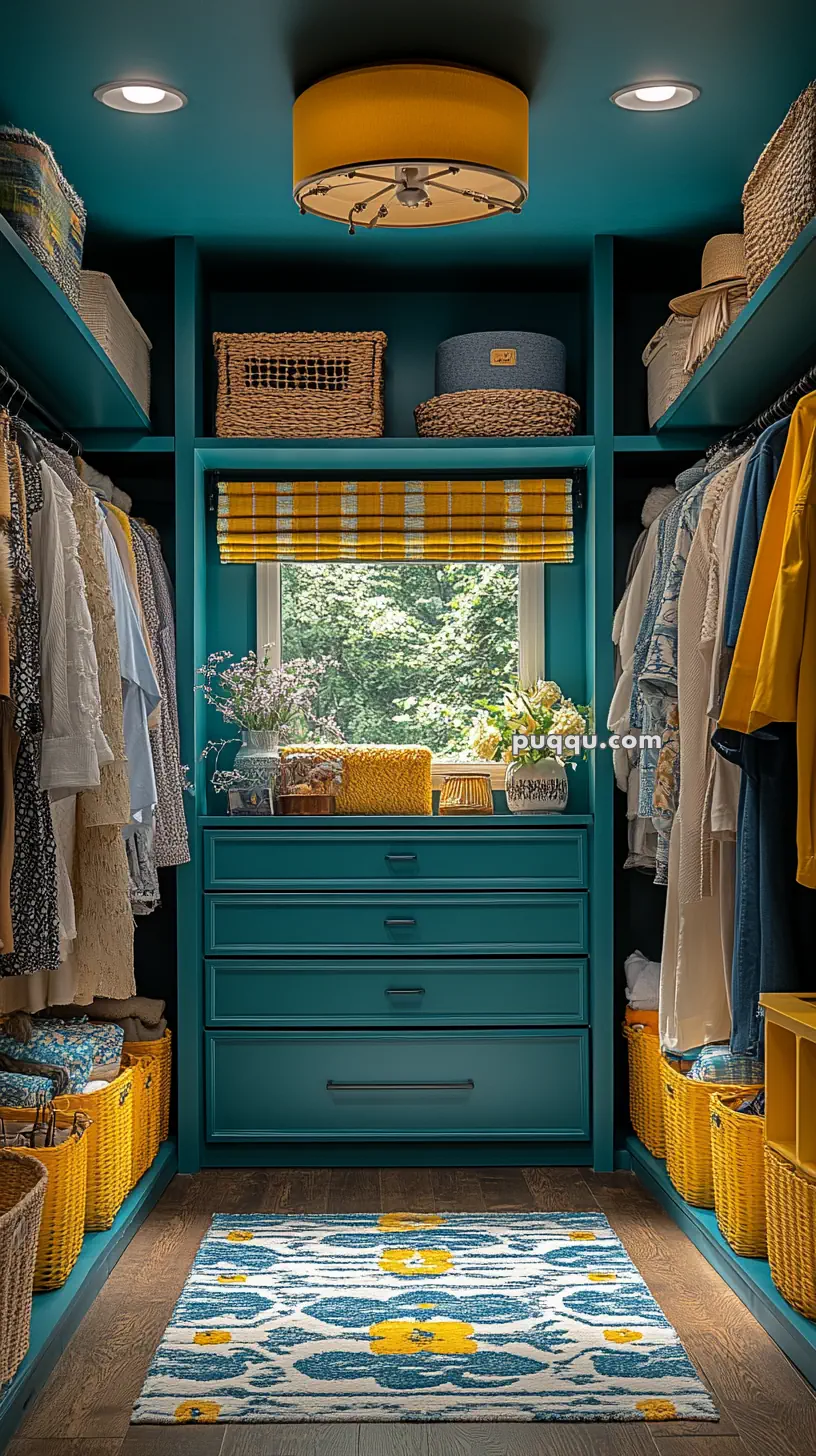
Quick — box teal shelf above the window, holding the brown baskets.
[195,435,595,473]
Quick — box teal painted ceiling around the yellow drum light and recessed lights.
[0,0,816,264]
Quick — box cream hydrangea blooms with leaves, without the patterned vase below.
[468,677,592,767]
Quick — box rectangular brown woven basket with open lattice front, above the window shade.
[213,333,386,438]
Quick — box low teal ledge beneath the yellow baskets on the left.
[0,1140,178,1452]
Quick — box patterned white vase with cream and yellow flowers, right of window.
[468,677,590,814]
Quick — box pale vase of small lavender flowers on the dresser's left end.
[198,648,341,807]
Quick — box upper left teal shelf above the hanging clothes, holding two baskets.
[0,217,150,437]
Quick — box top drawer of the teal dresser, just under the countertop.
[204,826,587,891]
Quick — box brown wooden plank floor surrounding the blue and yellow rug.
[10,1168,816,1456]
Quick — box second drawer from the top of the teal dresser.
[204,891,587,957]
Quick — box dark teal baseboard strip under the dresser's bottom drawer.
[201,1142,592,1168]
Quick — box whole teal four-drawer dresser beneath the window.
[203,815,592,1163]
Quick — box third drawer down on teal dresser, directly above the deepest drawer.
[205,958,587,1026]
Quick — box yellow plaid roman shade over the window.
[219,480,573,562]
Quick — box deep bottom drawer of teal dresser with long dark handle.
[207,1031,589,1142]
